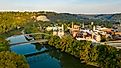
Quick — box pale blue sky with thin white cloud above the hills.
[0,0,121,14]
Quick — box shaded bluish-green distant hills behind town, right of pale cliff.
[41,12,121,22]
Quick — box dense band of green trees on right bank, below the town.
[48,36,121,68]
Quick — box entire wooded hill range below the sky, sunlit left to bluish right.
[0,11,121,34]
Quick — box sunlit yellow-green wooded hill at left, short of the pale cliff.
[0,12,32,33]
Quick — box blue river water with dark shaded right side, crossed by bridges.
[8,35,96,68]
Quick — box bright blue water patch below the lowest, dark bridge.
[27,53,61,68]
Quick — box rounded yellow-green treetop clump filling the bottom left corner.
[0,51,29,68]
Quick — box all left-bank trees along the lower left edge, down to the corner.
[0,38,29,68]
